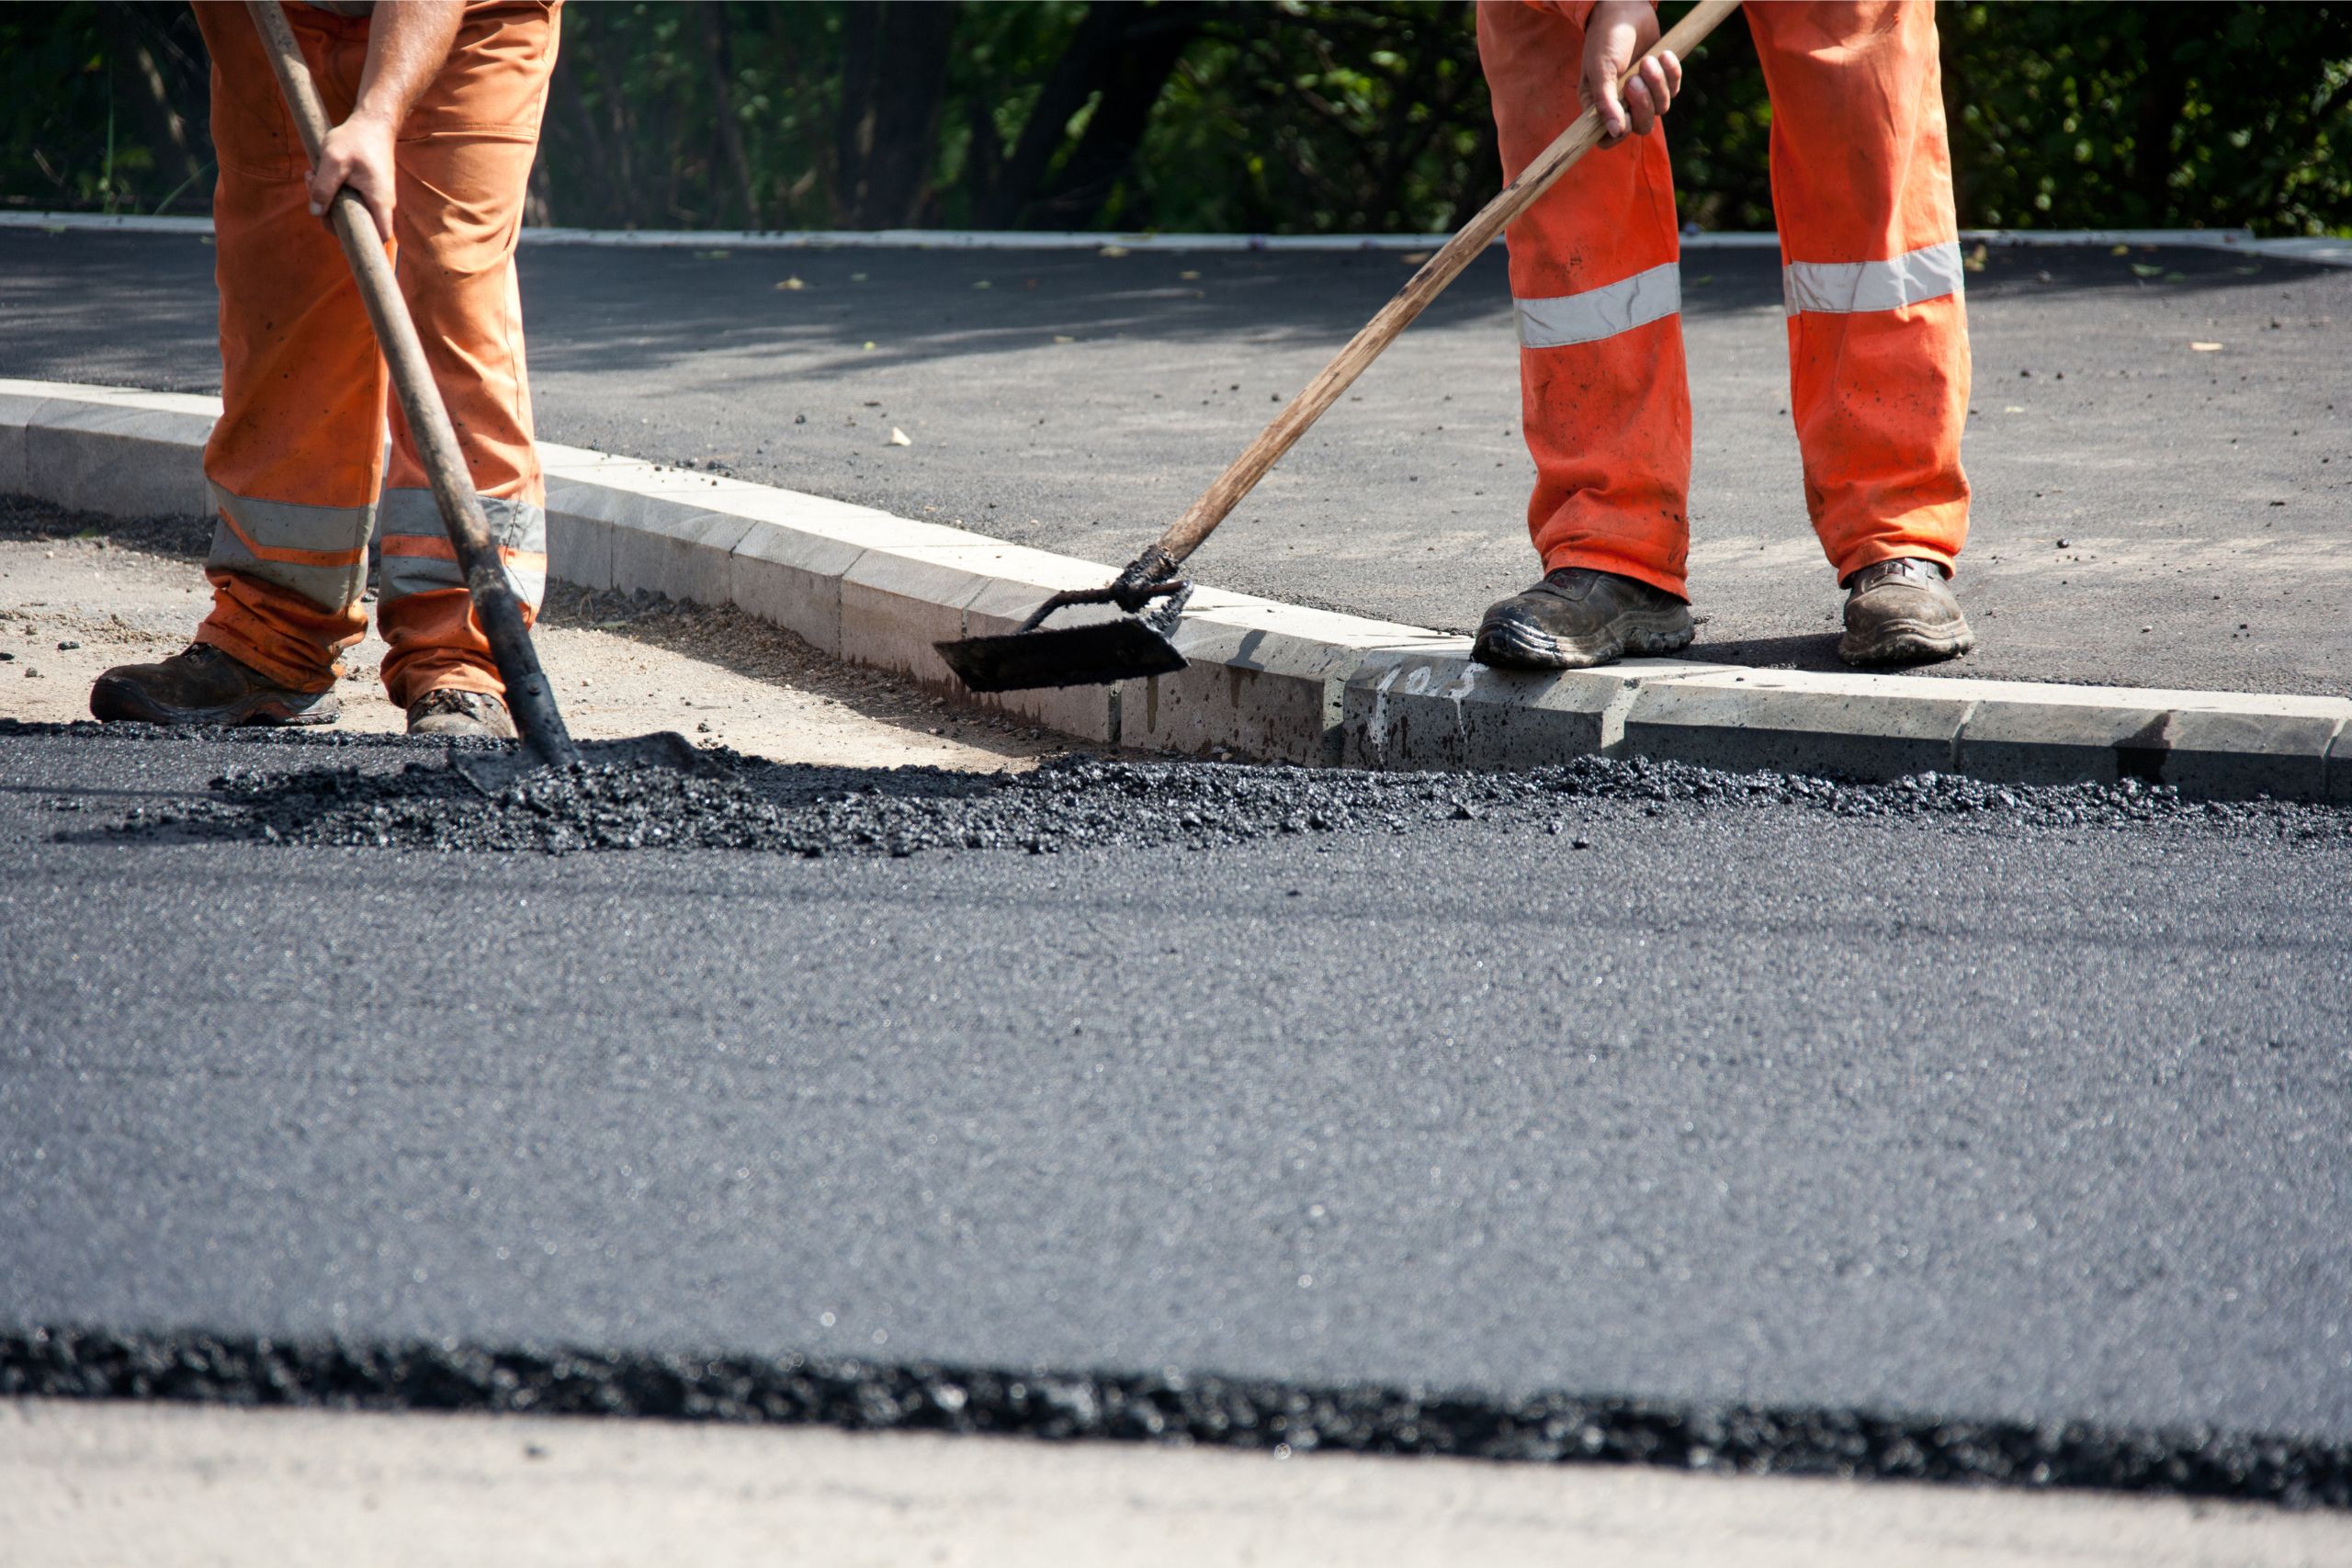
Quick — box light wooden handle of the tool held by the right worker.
[1131,0,1740,579]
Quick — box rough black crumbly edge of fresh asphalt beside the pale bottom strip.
[0,1328,2352,1509]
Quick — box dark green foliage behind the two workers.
[0,0,2352,232]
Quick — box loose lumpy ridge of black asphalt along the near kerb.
[41,724,2352,858]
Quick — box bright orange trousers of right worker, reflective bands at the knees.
[1477,0,1969,597]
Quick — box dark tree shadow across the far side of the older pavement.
[0,231,2326,388]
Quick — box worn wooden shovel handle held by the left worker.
[247,0,579,764]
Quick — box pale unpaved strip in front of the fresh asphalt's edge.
[0,1401,2352,1568]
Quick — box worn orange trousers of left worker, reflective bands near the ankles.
[195,3,558,707]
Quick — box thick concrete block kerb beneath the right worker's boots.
[14,378,2352,804]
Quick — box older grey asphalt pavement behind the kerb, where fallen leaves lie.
[0,231,2352,694]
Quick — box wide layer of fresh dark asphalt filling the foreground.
[14,728,2352,1502]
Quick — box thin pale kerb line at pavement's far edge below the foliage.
[0,211,2352,265]
